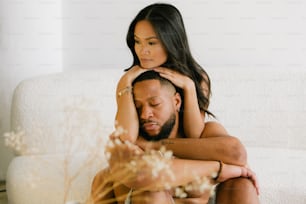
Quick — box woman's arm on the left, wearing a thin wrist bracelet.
[115,66,146,143]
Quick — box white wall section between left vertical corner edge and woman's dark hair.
[63,0,148,70]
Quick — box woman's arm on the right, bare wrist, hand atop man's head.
[154,67,204,138]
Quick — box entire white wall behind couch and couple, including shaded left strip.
[0,0,306,178]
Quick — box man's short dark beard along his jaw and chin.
[139,113,176,141]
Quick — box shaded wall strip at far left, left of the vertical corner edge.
[0,0,62,180]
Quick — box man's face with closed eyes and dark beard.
[133,80,181,141]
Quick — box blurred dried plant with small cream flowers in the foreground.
[4,107,214,204]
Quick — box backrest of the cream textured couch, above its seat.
[12,68,306,153]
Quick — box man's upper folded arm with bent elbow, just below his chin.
[138,122,247,166]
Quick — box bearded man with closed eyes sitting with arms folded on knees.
[92,71,258,203]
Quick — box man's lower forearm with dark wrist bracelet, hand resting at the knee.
[119,159,258,191]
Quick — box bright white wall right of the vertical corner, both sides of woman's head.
[63,0,306,70]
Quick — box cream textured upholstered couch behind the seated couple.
[7,68,306,204]
